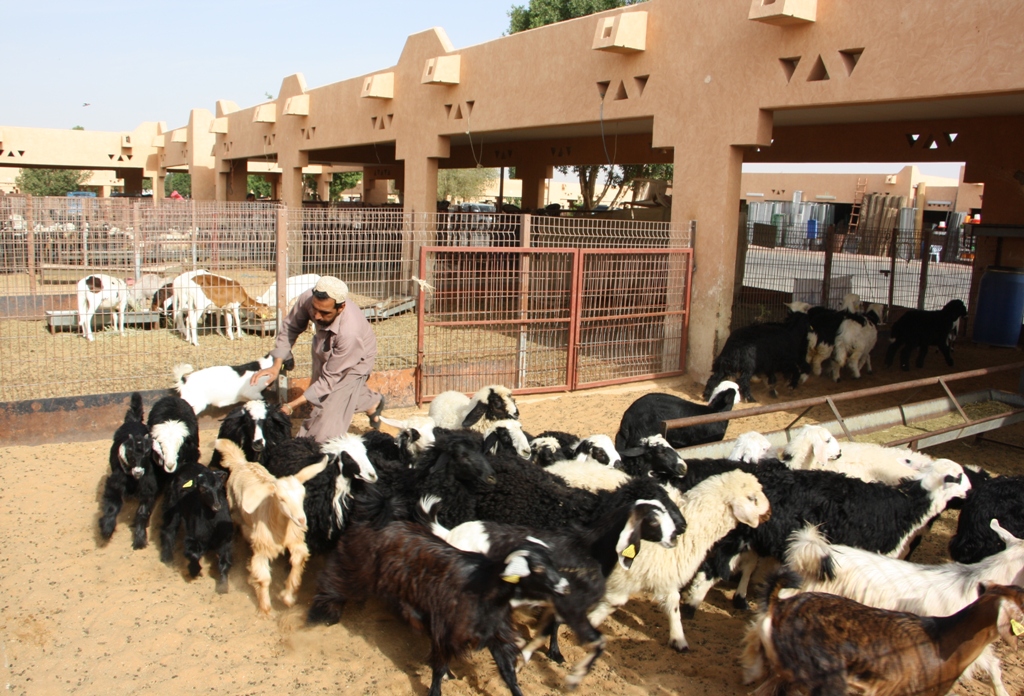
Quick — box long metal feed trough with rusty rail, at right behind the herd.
[662,362,1024,459]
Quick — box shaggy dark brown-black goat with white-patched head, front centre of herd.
[307,511,568,696]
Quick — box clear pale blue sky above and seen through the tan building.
[0,0,958,177]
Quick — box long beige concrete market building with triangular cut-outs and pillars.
[0,0,1024,378]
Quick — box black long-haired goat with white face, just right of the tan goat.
[263,433,377,554]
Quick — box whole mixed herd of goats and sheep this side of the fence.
[99,276,1024,696]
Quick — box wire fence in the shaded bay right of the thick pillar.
[732,222,974,328]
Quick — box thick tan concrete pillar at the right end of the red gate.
[672,141,743,382]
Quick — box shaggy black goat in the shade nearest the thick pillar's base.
[703,312,811,401]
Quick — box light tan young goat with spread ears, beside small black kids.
[215,439,329,614]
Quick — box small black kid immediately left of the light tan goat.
[160,463,234,594]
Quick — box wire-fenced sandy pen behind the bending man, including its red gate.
[0,195,692,405]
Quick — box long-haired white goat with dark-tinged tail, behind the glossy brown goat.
[786,520,1024,696]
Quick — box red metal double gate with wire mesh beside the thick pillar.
[417,247,692,402]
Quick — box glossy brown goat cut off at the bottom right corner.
[741,571,1024,696]
